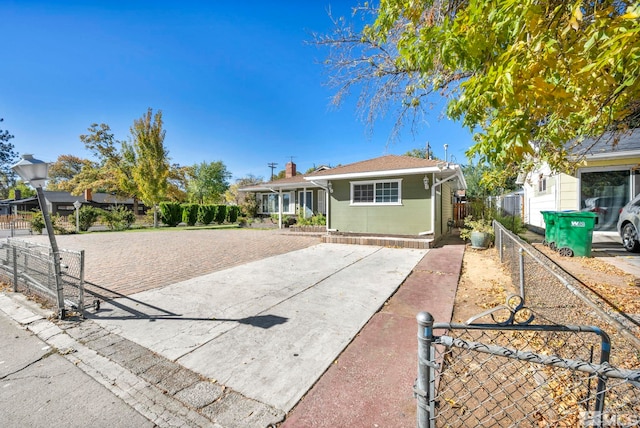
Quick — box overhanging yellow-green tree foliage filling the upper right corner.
[316,0,640,183]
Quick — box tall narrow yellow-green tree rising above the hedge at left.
[129,108,169,226]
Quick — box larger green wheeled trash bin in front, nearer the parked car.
[555,211,598,257]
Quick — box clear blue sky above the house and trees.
[0,0,472,178]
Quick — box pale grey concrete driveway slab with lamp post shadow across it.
[86,244,426,412]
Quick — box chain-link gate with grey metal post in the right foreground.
[415,312,640,428]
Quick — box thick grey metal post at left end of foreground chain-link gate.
[414,312,433,428]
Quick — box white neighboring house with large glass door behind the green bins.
[523,129,640,232]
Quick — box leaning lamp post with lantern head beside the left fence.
[11,155,65,319]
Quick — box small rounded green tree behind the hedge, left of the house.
[187,161,231,204]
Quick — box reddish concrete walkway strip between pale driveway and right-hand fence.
[283,242,464,428]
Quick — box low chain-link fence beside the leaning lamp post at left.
[0,238,86,317]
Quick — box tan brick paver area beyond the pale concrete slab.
[29,229,320,299]
